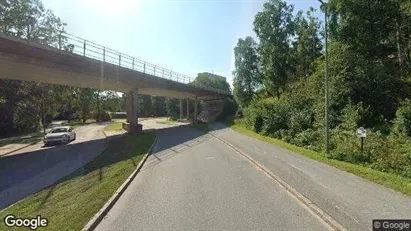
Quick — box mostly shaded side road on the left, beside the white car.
[0,123,106,209]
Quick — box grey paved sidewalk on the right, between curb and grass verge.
[209,123,411,230]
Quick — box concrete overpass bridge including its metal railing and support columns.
[0,32,231,132]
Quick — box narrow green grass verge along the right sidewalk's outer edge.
[226,120,411,196]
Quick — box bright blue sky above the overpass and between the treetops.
[43,0,321,84]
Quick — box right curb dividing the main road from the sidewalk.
[209,132,346,231]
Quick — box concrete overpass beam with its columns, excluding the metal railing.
[0,36,230,133]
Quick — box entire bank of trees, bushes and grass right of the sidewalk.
[233,0,411,191]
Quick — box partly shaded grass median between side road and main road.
[0,133,156,231]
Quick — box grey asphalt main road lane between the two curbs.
[96,127,328,230]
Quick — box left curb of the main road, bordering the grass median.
[82,132,158,231]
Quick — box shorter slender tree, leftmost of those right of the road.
[233,37,260,107]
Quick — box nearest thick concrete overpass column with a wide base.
[123,89,143,134]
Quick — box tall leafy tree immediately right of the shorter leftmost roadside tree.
[254,0,294,98]
